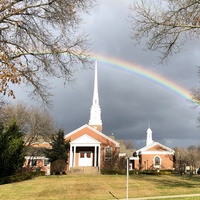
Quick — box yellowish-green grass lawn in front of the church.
[0,175,200,200]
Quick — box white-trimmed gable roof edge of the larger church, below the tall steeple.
[64,124,119,147]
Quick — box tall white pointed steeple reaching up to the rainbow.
[89,61,102,132]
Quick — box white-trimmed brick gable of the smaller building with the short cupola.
[136,142,175,155]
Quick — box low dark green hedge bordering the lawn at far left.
[0,172,45,185]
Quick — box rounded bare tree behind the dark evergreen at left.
[0,103,55,146]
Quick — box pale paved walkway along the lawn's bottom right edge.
[120,194,200,200]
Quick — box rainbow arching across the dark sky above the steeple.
[88,54,197,104]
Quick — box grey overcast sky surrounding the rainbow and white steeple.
[10,0,200,148]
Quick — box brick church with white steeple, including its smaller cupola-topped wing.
[23,62,174,173]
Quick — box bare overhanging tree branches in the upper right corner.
[130,0,200,59]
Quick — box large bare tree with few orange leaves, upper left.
[0,0,93,103]
